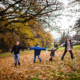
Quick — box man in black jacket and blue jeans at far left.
[11,41,27,66]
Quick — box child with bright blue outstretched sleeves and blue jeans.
[29,44,46,63]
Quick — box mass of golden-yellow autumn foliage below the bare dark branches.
[0,19,53,52]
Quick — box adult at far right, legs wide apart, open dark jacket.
[61,37,79,60]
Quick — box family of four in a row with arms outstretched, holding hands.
[11,37,80,66]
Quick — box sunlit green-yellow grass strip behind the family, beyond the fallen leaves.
[0,45,80,57]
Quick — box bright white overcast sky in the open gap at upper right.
[47,0,80,38]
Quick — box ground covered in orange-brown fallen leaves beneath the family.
[0,48,80,80]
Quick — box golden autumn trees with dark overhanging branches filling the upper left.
[0,0,79,51]
